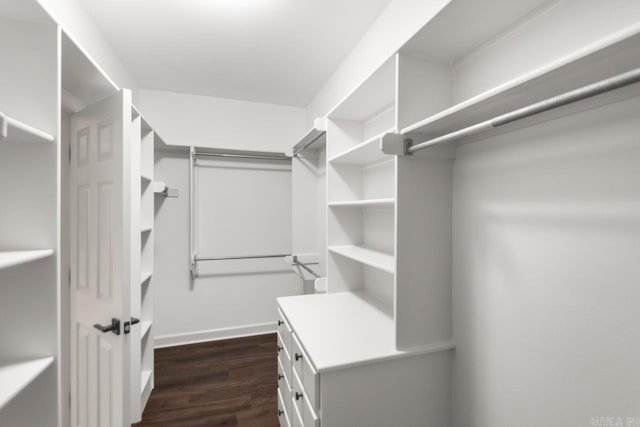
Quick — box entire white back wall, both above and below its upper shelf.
[141,90,305,346]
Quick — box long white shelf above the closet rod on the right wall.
[401,25,640,143]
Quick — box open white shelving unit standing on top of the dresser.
[326,59,397,314]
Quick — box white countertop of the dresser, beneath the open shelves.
[278,292,455,372]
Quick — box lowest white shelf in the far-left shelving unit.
[0,357,54,409]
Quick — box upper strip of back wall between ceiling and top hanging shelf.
[140,89,306,152]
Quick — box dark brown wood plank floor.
[135,334,279,427]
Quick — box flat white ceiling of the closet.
[81,0,390,106]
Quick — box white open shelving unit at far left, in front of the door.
[0,2,60,426]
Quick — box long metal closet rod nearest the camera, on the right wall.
[405,68,640,154]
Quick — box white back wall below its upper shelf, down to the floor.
[152,152,303,346]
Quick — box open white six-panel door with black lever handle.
[70,90,131,427]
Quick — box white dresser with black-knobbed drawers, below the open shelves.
[278,292,453,427]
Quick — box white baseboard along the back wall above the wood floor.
[154,322,277,348]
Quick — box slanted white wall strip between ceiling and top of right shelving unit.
[307,0,449,127]
